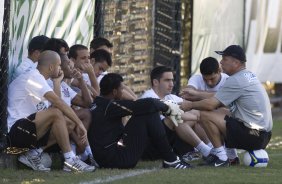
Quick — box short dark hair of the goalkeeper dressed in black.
[100,73,123,96]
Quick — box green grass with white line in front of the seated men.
[0,120,282,184]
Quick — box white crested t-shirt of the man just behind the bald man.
[47,79,77,106]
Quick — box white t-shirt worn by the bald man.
[7,69,53,131]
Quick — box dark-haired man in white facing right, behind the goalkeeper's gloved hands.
[141,66,211,161]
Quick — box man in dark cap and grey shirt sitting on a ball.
[181,45,273,167]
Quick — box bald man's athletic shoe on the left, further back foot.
[18,153,51,171]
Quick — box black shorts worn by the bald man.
[8,113,50,149]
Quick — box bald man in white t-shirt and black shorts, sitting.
[7,51,95,171]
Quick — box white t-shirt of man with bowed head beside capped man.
[188,73,229,92]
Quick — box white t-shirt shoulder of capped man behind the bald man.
[12,58,37,80]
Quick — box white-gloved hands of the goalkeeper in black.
[163,100,184,126]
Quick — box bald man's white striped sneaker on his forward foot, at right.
[63,157,96,172]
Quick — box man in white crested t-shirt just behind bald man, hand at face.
[48,54,98,167]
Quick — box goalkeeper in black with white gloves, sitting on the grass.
[88,73,191,169]
